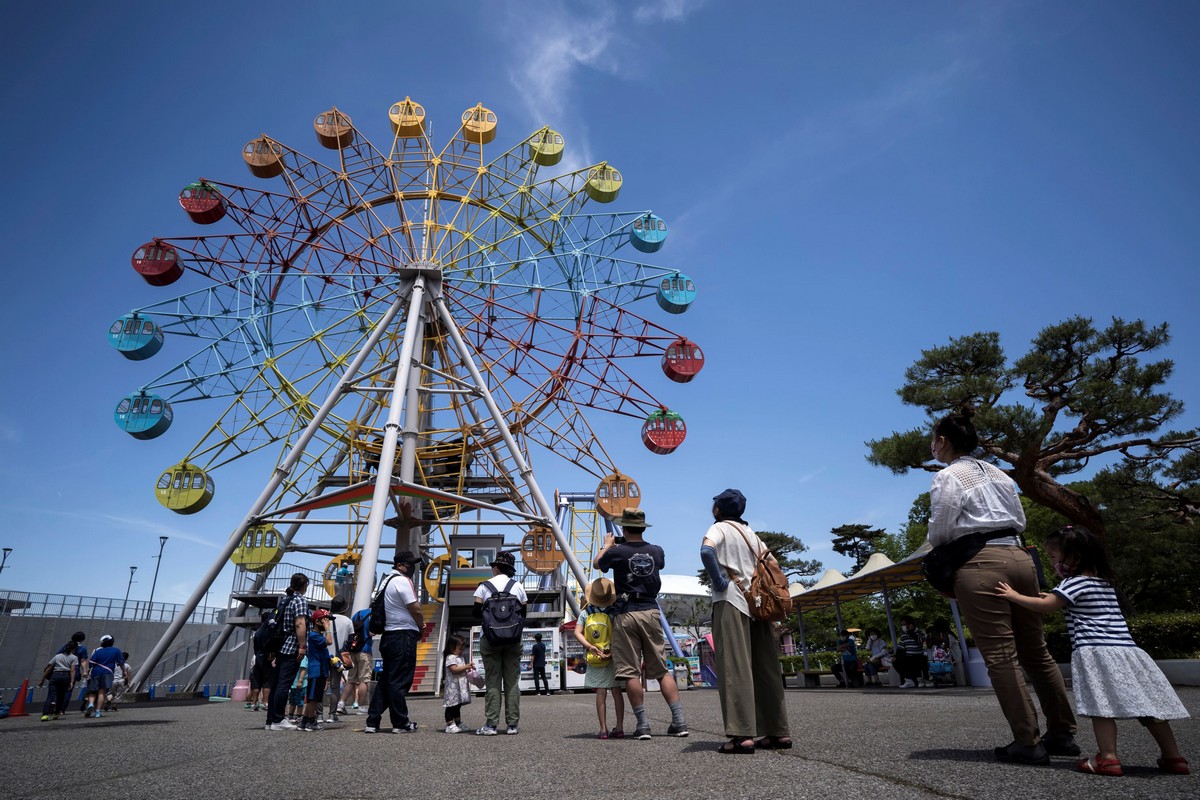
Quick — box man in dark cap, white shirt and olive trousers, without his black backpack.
[472,552,529,736]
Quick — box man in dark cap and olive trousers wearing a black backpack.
[472,552,529,736]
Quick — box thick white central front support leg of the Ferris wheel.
[353,272,425,614]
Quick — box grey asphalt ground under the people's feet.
[0,688,1200,800]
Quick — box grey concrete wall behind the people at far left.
[0,616,246,700]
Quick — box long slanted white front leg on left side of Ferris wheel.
[133,286,404,688]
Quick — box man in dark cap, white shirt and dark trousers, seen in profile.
[364,551,425,733]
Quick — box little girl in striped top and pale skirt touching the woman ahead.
[997,525,1189,776]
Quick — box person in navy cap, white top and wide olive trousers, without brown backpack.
[700,489,792,756]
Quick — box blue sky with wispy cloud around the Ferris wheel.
[0,0,1200,602]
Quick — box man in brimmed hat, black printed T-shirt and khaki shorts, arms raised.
[593,509,688,740]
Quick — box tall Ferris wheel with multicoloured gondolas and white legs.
[109,98,703,685]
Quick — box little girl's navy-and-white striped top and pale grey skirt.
[1054,576,1188,720]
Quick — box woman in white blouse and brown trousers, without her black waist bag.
[929,407,1080,764]
